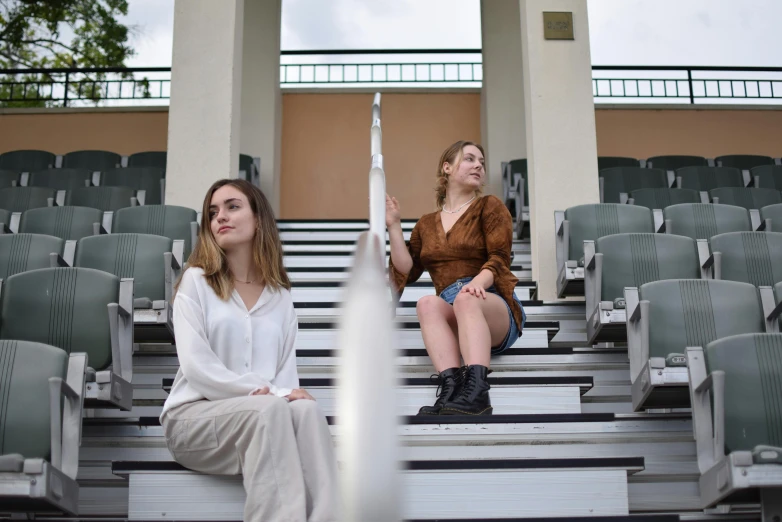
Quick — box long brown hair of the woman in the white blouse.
[177,179,291,300]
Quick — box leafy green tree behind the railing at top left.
[0,0,134,107]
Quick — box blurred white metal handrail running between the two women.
[337,93,402,522]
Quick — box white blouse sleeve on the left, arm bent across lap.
[173,284,280,401]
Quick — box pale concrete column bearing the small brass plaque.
[519,0,599,299]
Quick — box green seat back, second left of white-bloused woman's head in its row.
[19,207,103,242]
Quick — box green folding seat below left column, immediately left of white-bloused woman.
[112,205,198,260]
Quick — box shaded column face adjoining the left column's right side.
[241,0,282,215]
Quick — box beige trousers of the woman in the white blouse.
[163,395,340,522]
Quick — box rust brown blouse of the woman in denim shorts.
[389,196,522,331]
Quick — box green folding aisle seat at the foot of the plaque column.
[554,203,654,297]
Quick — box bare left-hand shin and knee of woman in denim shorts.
[415,295,462,373]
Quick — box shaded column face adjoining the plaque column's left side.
[481,0,527,196]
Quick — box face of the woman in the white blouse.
[209,185,258,251]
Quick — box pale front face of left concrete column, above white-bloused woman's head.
[166,0,244,210]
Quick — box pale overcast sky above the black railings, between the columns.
[121,0,782,67]
